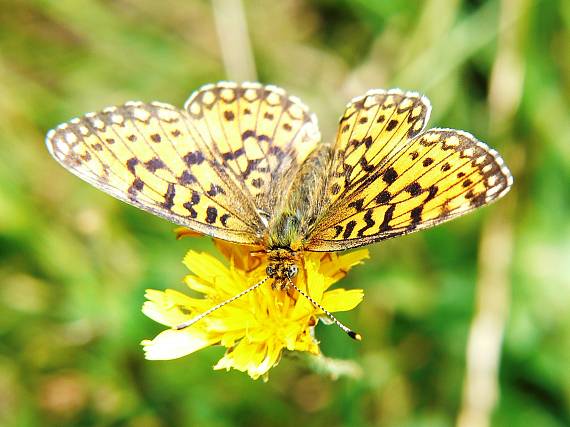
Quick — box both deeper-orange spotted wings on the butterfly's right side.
[306,90,512,251]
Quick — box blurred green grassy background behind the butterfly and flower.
[0,0,570,427]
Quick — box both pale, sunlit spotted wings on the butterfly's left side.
[46,83,318,244]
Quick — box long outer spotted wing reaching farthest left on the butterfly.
[47,98,257,243]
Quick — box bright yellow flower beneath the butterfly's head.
[142,241,368,379]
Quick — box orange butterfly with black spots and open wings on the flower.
[46,82,513,340]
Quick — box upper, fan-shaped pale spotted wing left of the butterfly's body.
[186,83,320,216]
